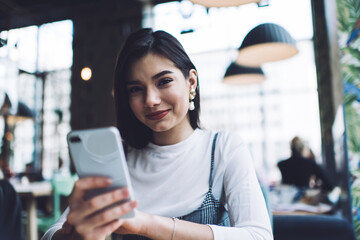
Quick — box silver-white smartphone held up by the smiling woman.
[67,127,134,218]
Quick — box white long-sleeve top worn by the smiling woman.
[43,129,273,240]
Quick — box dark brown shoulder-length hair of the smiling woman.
[114,28,200,148]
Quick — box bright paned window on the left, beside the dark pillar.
[0,20,73,178]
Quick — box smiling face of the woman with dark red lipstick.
[127,54,197,132]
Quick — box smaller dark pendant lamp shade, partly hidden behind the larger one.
[223,62,265,85]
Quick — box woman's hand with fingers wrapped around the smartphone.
[67,177,137,240]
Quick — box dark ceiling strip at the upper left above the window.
[0,0,174,31]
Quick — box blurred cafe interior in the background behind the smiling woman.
[0,0,360,240]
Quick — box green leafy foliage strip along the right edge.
[337,0,360,237]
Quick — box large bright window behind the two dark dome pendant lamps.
[150,0,321,184]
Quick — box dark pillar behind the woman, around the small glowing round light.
[70,1,142,129]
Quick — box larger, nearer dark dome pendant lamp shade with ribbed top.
[236,23,299,67]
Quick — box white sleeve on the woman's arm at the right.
[210,133,273,240]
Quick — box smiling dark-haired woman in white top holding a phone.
[44,29,272,240]
